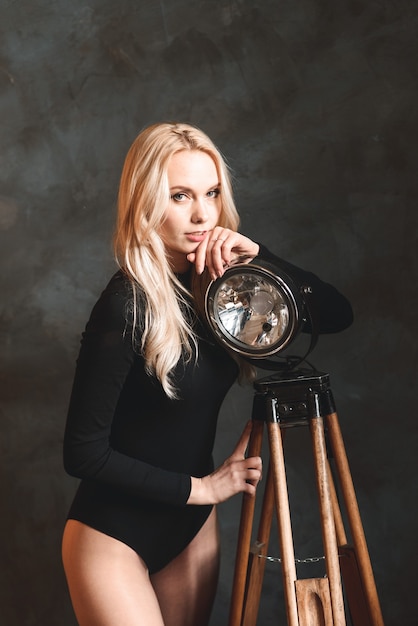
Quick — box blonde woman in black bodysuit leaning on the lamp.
[63,123,352,626]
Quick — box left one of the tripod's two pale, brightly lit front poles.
[267,422,299,626]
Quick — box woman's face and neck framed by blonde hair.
[160,150,222,272]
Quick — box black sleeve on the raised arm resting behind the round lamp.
[254,244,353,334]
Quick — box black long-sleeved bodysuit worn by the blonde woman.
[64,247,352,573]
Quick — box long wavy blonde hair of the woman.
[114,122,239,398]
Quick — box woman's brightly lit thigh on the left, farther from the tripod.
[62,520,164,626]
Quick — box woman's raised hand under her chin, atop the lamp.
[187,226,259,280]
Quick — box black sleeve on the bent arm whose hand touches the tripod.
[64,273,191,504]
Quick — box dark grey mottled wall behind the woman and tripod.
[0,0,418,626]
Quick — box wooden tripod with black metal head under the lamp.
[229,370,384,626]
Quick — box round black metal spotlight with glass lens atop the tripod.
[204,261,318,369]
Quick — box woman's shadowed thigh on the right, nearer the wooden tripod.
[151,508,220,626]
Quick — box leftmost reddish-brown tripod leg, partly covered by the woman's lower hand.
[228,420,264,626]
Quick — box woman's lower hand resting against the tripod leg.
[187,422,262,505]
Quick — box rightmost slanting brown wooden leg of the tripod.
[326,412,384,626]
